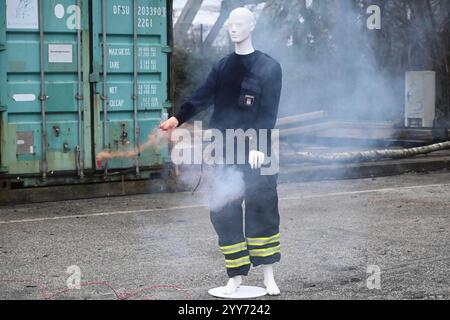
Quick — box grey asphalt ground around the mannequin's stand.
[0,171,450,299]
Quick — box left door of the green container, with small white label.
[0,0,92,177]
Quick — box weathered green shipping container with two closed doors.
[0,0,171,185]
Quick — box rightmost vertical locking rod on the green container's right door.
[133,0,141,176]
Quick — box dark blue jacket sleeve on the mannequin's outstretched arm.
[175,63,218,125]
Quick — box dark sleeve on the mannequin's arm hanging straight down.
[255,63,283,148]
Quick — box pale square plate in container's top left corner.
[6,0,39,30]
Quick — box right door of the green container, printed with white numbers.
[91,0,170,173]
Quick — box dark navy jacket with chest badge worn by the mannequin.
[175,50,282,136]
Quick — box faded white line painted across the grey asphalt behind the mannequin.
[0,184,450,225]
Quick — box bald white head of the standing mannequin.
[227,8,256,43]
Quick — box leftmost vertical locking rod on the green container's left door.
[39,0,48,179]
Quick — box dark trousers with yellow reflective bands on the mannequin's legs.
[208,165,281,278]
